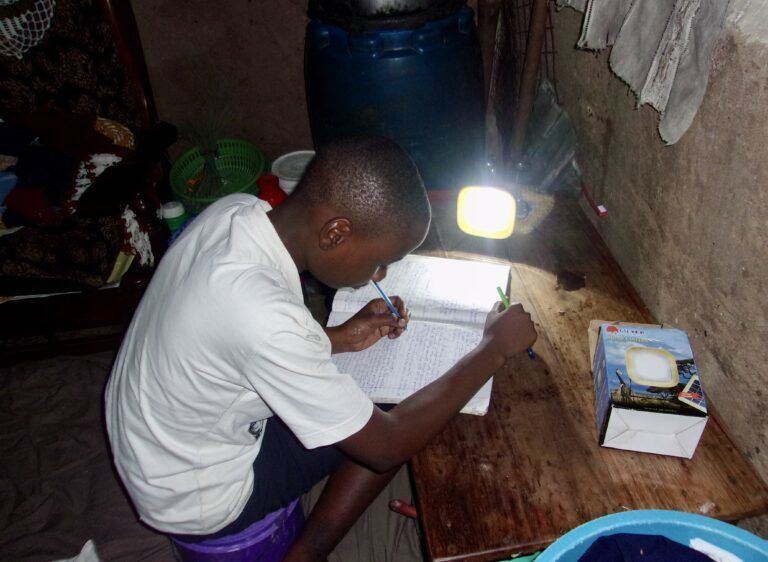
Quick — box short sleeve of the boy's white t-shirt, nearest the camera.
[231,284,373,448]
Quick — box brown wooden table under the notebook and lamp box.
[411,194,768,561]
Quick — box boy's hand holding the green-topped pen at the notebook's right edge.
[481,302,537,364]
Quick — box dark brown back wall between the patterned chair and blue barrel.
[132,0,312,159]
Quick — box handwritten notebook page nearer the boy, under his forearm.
[329,312,492,415]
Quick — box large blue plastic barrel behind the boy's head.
[305,7,485,189]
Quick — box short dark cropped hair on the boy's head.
[296,137,431,235]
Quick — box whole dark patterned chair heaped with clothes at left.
[0,0,176,364]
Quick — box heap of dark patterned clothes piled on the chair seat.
[0,112,165,294]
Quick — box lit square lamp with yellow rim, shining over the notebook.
[456,186,515,238]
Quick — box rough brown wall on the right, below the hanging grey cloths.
[555,6,768,534]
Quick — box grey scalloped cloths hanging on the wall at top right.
[561,0,728,144]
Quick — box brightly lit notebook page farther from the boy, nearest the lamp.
[329,255,509,327]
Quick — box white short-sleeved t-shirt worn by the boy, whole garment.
[106,195,373,534]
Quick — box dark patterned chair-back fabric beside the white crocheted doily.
[0,0,140,129]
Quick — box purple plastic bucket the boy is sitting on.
[173,499,304,562]
